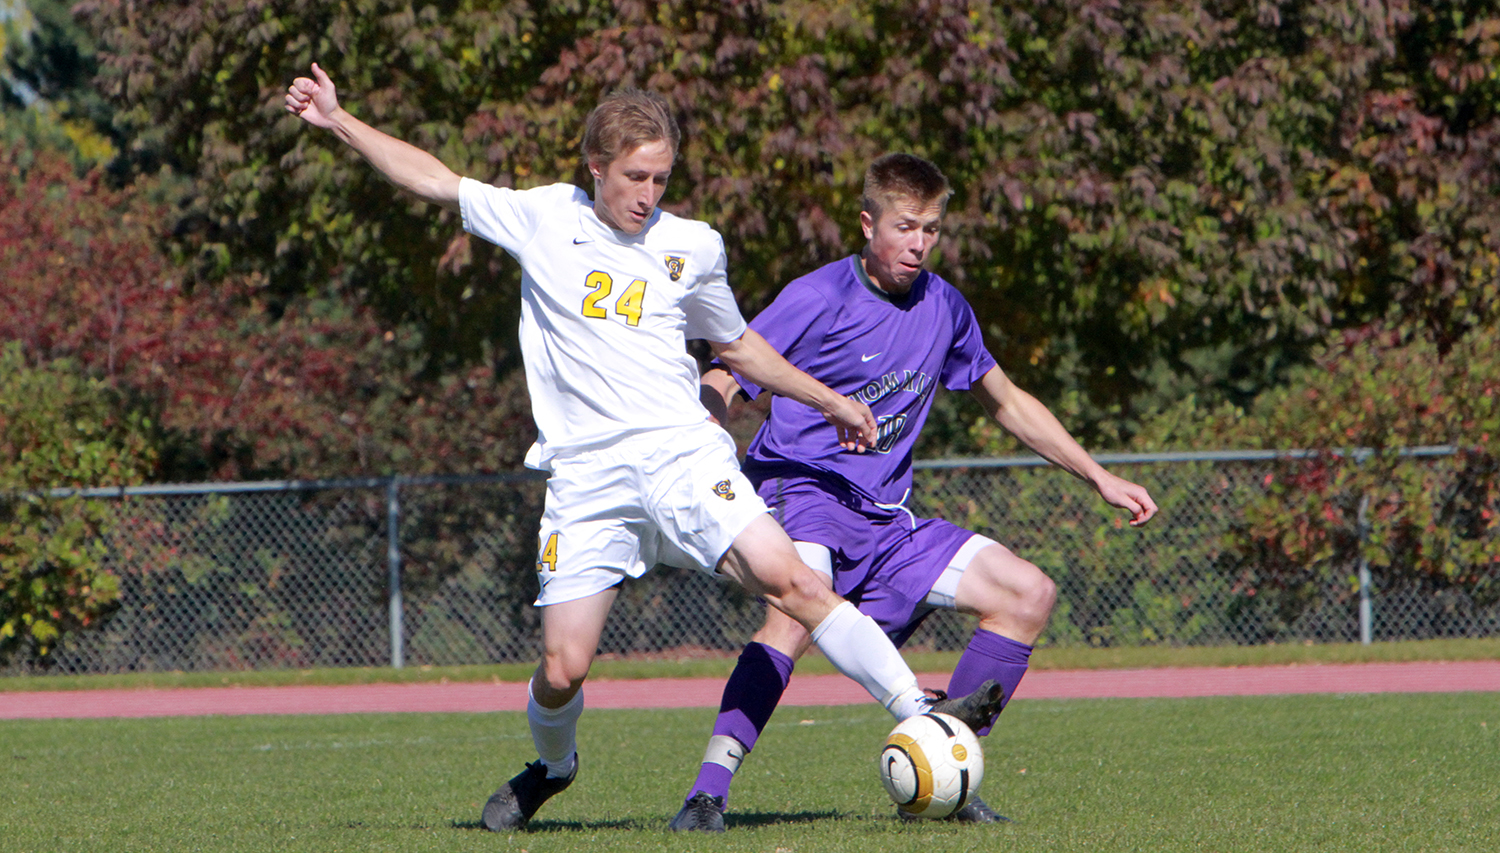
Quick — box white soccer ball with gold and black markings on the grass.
[881,714,984,819]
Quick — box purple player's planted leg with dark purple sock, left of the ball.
[671,543,833,831]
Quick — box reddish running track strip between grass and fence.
[0,661,1500,720]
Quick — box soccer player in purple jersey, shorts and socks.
[671,154,1157,832]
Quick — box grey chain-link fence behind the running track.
[0,453,1500,675]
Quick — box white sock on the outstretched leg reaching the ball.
[813,601,923,720]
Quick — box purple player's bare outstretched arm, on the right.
[971,361,1157,526]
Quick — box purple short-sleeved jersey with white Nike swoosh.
[735,255,995,504]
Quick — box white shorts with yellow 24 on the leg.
[536,421,767,607]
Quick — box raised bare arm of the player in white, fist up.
[287,63,461,210]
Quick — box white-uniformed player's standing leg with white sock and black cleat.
[482,586,620,832]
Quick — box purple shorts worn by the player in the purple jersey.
[762,471,974,646]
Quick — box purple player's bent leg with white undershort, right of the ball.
[929,537,1058,735]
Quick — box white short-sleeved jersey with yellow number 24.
[459,178,746,468]
